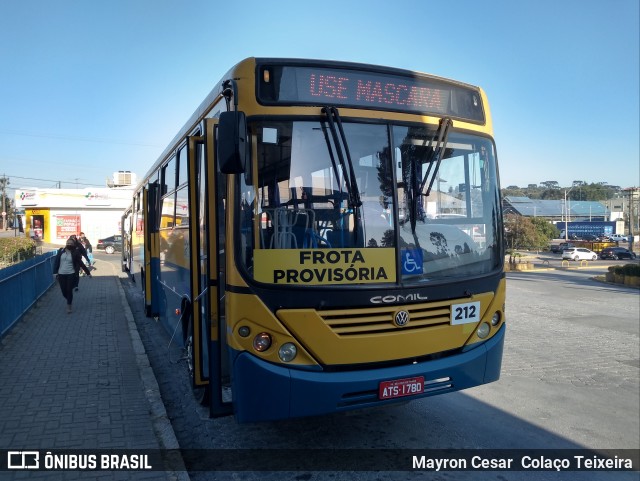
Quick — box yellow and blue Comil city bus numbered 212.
[122,58,505,422]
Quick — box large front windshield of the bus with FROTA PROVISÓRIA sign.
[239,120,502,284]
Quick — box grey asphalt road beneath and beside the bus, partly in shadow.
[101,248,640,481]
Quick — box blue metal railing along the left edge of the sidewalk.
[0,251,55,337]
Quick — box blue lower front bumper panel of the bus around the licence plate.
[233,325,506,422]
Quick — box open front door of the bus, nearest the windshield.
[188,119,233,417]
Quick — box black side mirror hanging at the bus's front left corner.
[217,111,249,174]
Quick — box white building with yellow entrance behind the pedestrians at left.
[15,172,135,244]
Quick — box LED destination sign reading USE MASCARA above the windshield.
[258,66,484,123]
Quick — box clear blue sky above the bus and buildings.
[0,0,640,197]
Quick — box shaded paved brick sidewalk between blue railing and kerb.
[0,253,188,480]
